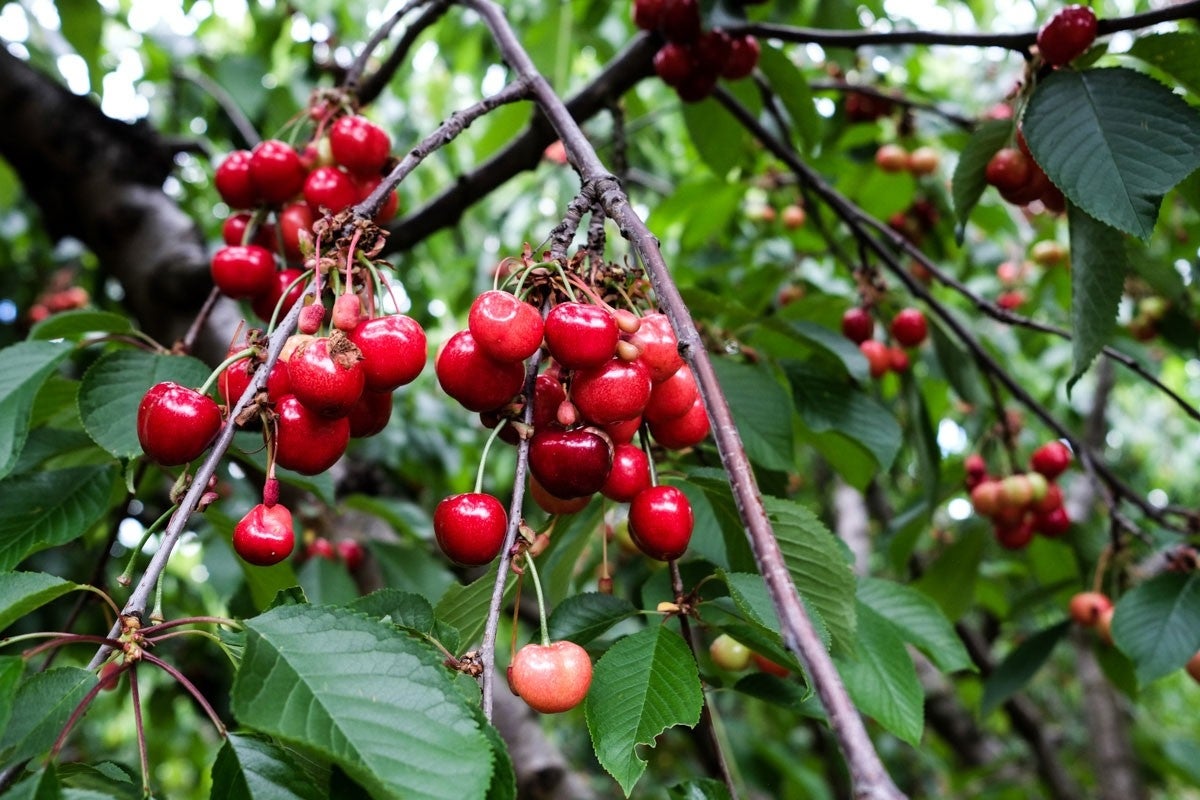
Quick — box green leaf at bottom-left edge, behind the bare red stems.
[0,667,96,766]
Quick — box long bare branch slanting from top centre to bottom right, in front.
[462,0,904,800]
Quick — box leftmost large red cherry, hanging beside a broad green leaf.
[137,381,221,467]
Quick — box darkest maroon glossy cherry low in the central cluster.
[529,428,612,500]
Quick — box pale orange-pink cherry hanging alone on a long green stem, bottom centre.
[509,639,592,714]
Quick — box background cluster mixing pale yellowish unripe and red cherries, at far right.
[966,440,1072,549]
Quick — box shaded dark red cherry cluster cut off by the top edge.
[634,0,761,103]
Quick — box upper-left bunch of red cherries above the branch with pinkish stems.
[210,113,398,321]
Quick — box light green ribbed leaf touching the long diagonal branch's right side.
[763,498,857,651]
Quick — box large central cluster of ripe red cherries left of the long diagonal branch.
[433,258,709,565]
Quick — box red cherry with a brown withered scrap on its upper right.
[288,330,366,416]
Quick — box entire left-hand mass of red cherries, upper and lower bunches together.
[138,95,427,566]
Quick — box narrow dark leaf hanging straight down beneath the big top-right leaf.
[1067,205,1129,391]
